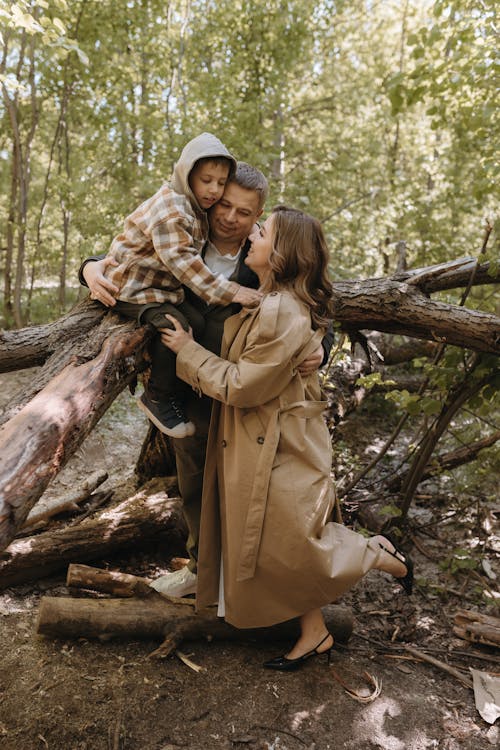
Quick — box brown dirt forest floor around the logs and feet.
[0,372,500,750]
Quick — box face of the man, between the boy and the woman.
[208,182,262,244]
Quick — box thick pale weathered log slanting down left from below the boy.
[0,325,152,549]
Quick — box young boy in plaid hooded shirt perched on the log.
[101,133,255,438]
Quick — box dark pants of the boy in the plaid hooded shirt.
[113,300,205,402]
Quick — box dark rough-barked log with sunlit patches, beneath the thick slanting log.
[0,479,187,589]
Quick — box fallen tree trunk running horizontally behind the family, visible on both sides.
[0,258,500,372]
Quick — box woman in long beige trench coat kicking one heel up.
[163,206,413,671]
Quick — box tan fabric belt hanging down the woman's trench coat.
[236,401,326,581]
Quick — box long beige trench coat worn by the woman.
[177,292,379,628]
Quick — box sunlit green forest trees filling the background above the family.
[0,0,498,327]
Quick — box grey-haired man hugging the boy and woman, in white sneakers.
[80,162,333,596]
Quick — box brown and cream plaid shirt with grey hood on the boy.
[105,133,239,305]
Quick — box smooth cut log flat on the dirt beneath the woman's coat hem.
[36,592,353,657]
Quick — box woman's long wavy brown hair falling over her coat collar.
[263,206,333,328]
